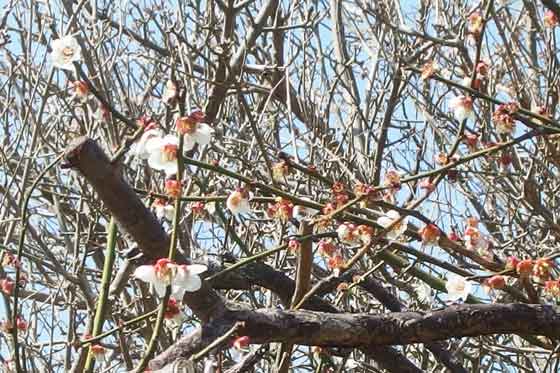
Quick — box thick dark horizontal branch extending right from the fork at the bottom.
[229,303,560,347]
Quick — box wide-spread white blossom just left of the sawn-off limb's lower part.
[134,258,207,300]
